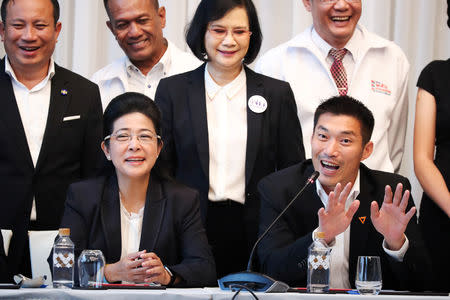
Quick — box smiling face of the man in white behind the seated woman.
[106,0,167,74]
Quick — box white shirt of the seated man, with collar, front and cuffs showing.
[313,171,409,289]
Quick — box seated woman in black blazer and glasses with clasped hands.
[57,93,216,287]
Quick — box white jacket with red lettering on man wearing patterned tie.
[255,24,409,172]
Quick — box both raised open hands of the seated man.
[318,182,416,251]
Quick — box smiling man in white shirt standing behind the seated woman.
[92,0,201,110]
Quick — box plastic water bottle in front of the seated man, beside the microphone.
[307,232,331,293]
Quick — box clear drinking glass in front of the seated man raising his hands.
[355,256,382,295]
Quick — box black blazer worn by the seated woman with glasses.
[54,175,216,287]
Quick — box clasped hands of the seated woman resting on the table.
[105,250,170,285]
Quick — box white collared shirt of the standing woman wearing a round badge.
[205,65,247,203]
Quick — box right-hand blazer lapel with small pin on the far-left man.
[36,64,72,171]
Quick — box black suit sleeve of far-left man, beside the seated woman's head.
[80,85,103,178]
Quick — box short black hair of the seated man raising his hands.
[314,96,375,145]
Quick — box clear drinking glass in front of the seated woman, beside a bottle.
[78,250,105,288]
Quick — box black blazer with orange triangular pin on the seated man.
[258,160,431,290]
